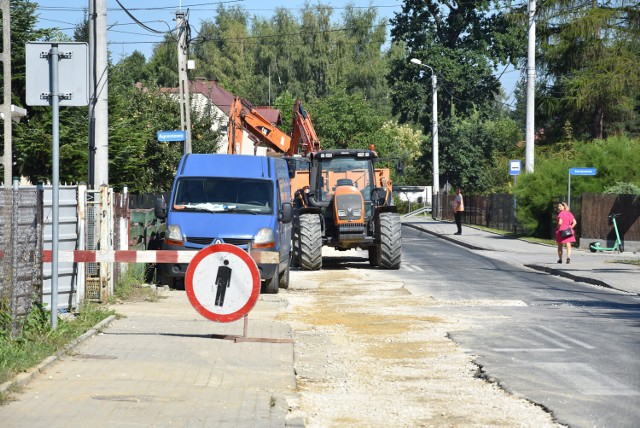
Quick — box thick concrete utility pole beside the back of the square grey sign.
[89,0,109,189]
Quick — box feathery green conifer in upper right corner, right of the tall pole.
[538,0,640,139]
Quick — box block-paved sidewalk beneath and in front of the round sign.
[0,291,303,427]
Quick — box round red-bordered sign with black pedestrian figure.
[184,244,260,322]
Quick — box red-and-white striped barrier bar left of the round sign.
[42,250,197,263]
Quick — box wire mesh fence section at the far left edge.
[0,188,43,337]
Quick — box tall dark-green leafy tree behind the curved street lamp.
[388,0,520,123]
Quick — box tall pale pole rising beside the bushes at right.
[525,0,536,172]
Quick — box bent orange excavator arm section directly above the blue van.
[227,97,291,154]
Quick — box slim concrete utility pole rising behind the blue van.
[176,10,191,154]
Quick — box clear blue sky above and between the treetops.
[33,0,520,104]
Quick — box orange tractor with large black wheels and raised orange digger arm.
[229,100,402,270]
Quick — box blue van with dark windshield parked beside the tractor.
[155,154,293,294]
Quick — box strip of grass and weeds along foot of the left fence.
[0,269,158,404]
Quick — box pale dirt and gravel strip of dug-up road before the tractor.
[279,269,556,428]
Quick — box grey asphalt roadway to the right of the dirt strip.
[398,227,640,427]
